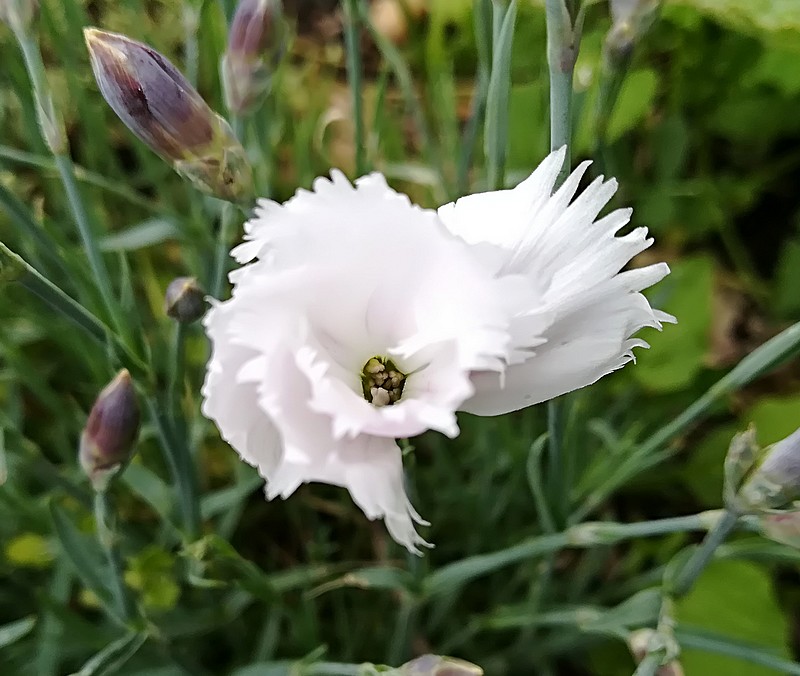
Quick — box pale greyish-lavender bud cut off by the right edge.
[737,430,800,510]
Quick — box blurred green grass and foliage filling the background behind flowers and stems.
[0,0,800,676]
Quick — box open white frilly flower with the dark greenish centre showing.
[203,172,535,552]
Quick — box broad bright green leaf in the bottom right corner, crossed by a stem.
[677,561,790,676]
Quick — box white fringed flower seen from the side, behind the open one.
[439,148,675,415]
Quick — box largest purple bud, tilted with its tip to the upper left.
[84,28,252,202]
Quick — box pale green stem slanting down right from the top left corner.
[16,29,127,336]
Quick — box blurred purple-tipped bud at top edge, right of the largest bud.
[222,0,287,113]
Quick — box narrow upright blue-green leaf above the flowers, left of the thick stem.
[483,0,517,190]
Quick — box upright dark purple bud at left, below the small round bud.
[78,369,139,491]
